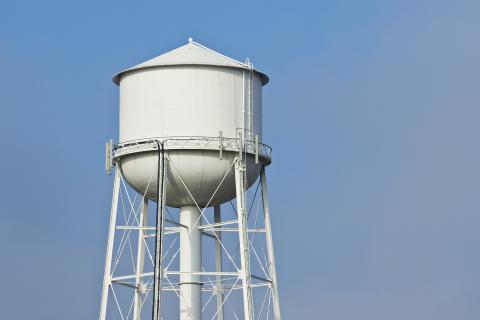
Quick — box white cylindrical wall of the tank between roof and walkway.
[120,65,262,142]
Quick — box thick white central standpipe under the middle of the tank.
[180,206,202,320]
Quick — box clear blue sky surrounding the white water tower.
[0,0,480,320]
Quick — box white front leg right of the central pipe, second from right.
[235,159,253,320]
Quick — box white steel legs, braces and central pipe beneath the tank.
[101,164,280,320]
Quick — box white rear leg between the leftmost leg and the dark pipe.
[133,198,148,320]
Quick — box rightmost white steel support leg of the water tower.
[260,167,281,320]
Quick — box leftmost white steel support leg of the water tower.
[99,167,121,320]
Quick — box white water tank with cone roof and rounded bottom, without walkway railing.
[114,43,268,207]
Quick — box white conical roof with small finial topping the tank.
[112,38,269,85]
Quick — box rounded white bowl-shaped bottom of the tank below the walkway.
[119,150,261,207]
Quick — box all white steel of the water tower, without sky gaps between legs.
[100,40,280,320]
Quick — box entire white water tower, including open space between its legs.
[100,39,280,320]
